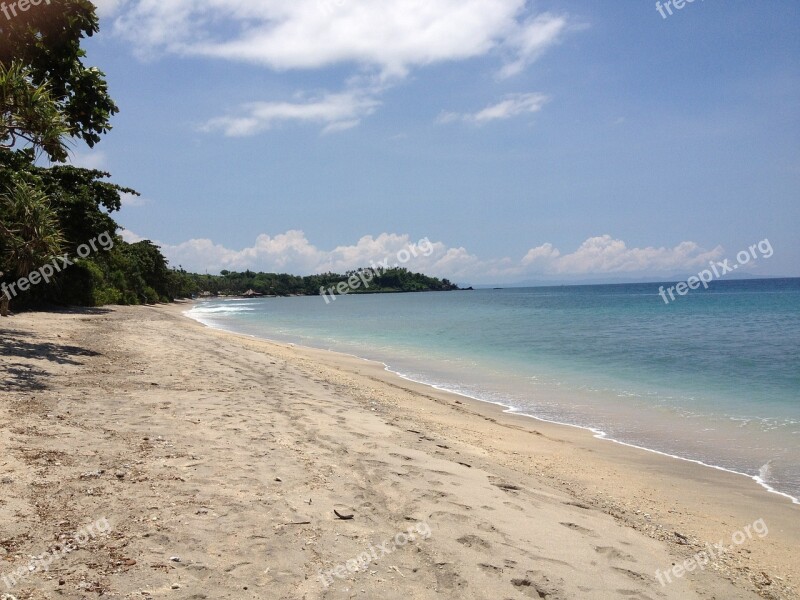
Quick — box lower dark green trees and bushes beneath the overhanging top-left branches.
[0,144,151,308]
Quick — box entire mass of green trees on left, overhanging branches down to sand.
[0,0,192,308]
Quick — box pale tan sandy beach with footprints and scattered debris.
[0,305,800,600]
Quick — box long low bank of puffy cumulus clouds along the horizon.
[123,230,723,283]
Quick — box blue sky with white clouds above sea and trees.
[71,0,800,285]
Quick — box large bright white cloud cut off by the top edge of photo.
[111,0,567,76]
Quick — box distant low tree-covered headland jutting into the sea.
[187,267,461,297]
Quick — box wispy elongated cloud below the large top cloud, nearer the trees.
[203,92,380,137]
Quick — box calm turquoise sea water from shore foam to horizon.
[189,279,800,498]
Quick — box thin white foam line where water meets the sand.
[182,301,800,505]
